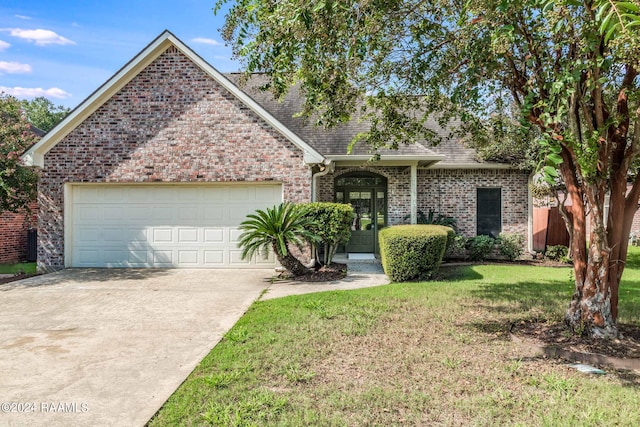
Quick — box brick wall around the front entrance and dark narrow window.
[317,166,529,247]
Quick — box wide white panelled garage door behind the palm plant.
[65,184,282,268]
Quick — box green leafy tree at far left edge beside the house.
[0,94,38,212]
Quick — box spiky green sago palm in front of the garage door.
[239,203,317,276]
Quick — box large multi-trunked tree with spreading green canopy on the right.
[216,0,640,342]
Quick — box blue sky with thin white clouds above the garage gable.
[0,0,239,108]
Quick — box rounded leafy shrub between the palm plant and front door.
[301,202,354,265]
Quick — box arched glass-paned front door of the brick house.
[336,172,387,253]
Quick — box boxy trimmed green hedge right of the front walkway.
[379,225,455,282]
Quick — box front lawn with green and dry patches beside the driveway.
[150,248,640,426]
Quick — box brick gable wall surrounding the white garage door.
[38,47,311,270]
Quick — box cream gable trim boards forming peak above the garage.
[23,30,328,166]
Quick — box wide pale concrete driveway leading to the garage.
[0,269,273,427]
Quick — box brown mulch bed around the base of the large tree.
[511,322,640,369]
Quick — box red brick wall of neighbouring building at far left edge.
[0,202,38,264]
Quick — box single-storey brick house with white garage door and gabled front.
[25,31,531,270]
